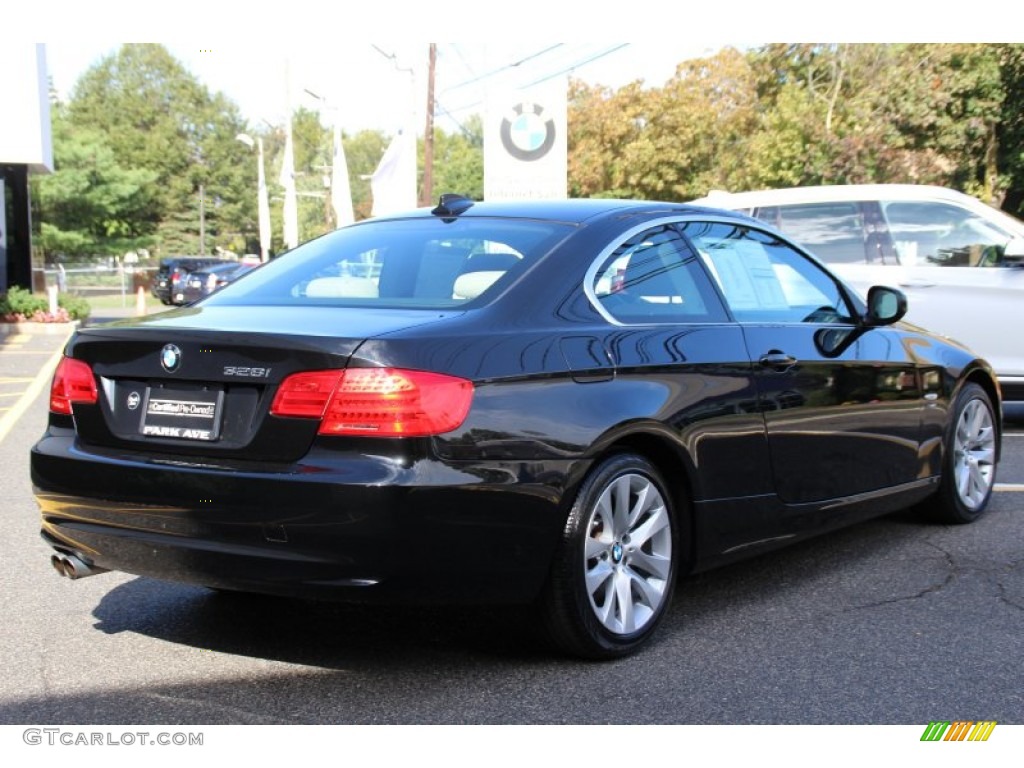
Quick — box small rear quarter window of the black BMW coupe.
[591,226,727,324]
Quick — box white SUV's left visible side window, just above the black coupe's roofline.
[757,202,880,264]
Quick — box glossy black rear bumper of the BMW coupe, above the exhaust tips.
[32,434,572,602]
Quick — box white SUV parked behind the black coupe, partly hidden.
[692,184,1024,400]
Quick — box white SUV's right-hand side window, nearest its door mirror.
[882,201,1011,266]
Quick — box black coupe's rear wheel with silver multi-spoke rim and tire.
[542,454,681,658]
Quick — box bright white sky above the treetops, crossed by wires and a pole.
[46,39,743,133]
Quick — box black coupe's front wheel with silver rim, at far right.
[925,383,999,524]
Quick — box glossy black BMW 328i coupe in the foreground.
[32,196,1000,657]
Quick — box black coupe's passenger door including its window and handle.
[683,222,924,505]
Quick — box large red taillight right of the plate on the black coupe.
[270,368,473,437]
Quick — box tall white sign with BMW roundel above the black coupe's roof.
[483,78,568,200]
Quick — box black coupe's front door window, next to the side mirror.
[683,222,852,324]
